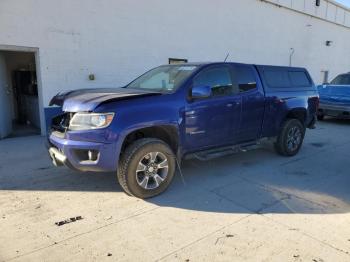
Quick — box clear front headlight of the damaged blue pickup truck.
[69,113,114,130]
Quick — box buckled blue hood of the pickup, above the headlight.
[50,88,162,112]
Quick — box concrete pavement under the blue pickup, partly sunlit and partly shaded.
[0,120,350,262]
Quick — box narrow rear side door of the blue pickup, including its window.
[234,64,265,143]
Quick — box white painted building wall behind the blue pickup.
[0,0,350,131]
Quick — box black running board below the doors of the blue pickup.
[185,141,260,161]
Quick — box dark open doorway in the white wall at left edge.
[0,50,41,139]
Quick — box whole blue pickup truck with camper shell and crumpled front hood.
[48,63,319,198]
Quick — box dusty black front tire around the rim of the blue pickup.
[117,138,176,199]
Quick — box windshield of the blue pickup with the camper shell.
[126,65,197,92]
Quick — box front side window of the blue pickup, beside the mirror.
[193,66,235,97]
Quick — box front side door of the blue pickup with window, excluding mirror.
[185,65,241,150]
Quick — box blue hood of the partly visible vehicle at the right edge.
[318,85,350,105]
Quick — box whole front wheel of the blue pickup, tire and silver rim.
[117,138,176,198]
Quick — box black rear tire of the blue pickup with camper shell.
[275,119,305,156]
